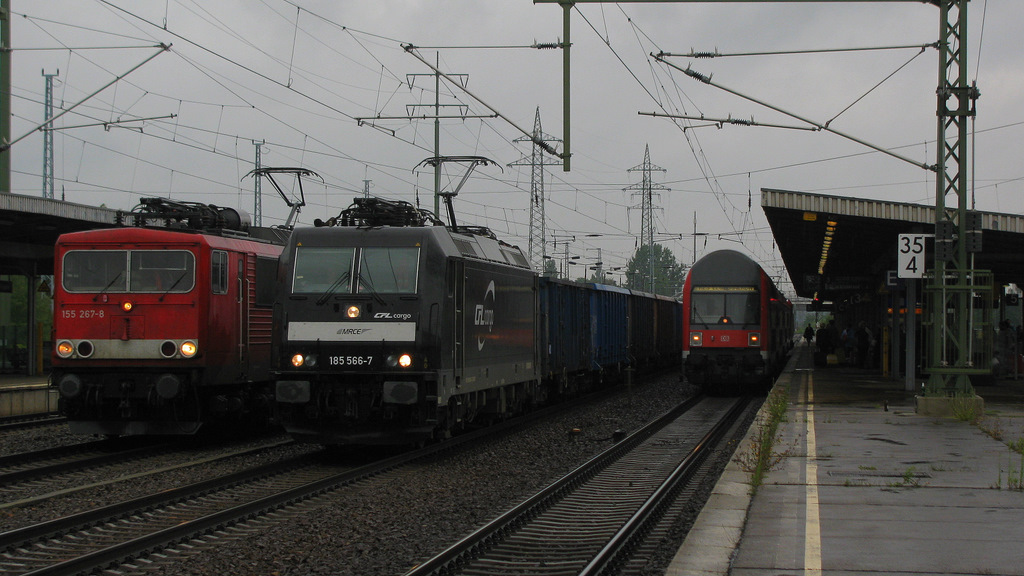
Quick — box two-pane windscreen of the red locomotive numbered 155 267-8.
[61,250,196,293]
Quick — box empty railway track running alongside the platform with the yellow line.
[407,399,749,576]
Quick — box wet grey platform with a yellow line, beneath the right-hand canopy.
[666,345,1024,576]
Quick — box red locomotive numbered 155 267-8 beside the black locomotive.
[52,198,287,436]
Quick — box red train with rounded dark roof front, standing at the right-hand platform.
[683,250,794,394]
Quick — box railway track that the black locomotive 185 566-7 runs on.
[0,377,622,576]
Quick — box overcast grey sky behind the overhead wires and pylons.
[4,0,1024,294]
